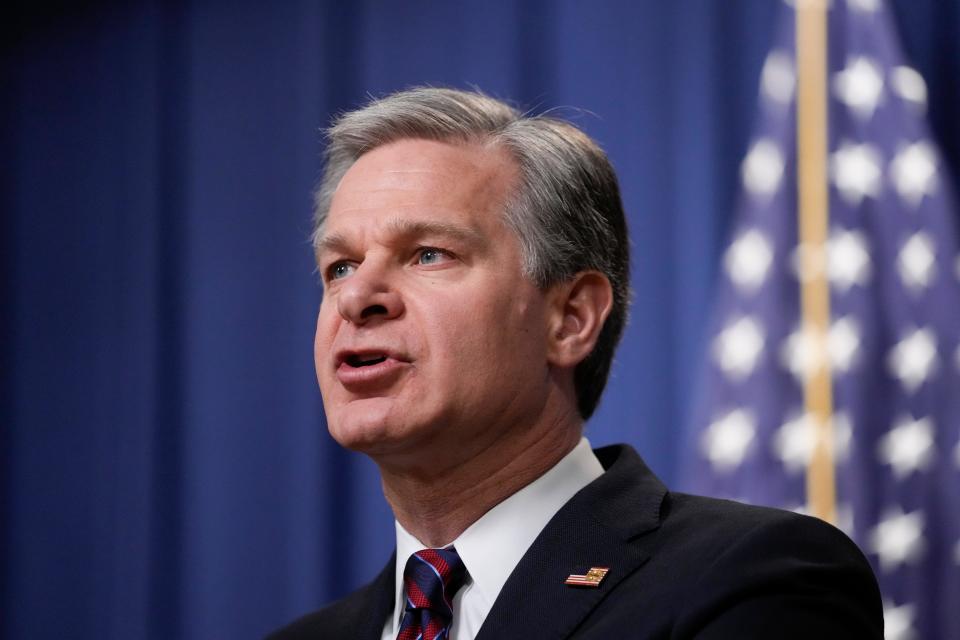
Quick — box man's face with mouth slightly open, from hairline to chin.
[314,140,548,465]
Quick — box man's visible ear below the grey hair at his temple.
[547,271,613,368]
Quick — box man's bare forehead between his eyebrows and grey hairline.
[324,139,517,232]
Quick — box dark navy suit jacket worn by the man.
[270,446,883,640]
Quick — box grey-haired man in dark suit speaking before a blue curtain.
[273,88,882,640]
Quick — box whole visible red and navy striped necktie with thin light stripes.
[397,547,467,640]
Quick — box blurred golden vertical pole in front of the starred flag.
[796,0,836,523]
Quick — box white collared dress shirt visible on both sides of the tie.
[381,438,603,640]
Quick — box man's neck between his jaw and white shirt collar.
[380,404,583,547]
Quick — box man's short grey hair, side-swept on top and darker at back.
[313,87,630,419]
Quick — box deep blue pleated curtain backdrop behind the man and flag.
[0,0,960,639]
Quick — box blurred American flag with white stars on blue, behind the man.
[684,0,960,640]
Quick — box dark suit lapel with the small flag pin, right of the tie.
[477,447,666,640]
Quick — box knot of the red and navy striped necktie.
[403,547,467,620]
